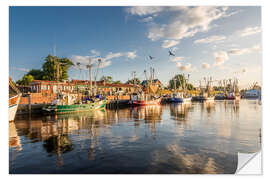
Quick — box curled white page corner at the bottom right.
[235,151,262,175]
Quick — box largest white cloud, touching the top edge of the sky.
[127,6,228,41]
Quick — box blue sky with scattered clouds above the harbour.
[9,6,262,87]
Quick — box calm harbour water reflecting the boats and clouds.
[9,100,261,174]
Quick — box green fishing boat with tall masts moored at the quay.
[42,59,106,114]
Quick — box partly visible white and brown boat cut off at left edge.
[8,79,21,122]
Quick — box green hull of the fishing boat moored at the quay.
[42,100,106,114]
